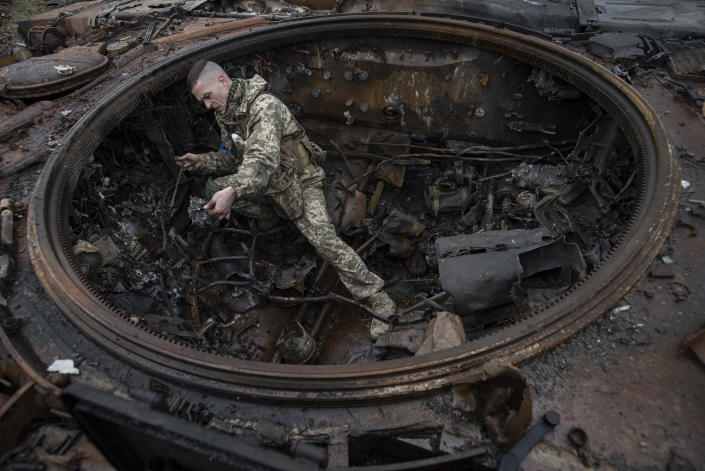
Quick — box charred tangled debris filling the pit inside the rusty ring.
[70,45,640,363]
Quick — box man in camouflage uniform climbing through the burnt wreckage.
[176,60,396,340]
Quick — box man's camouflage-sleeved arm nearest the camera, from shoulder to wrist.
[214,95,288,198]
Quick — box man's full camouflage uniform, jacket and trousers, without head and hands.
[194,75,394,306]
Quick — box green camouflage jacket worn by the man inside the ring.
[201,75,320,205]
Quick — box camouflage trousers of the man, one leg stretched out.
[226,167,384,300]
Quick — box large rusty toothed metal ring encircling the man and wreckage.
[28,14,679,405]
